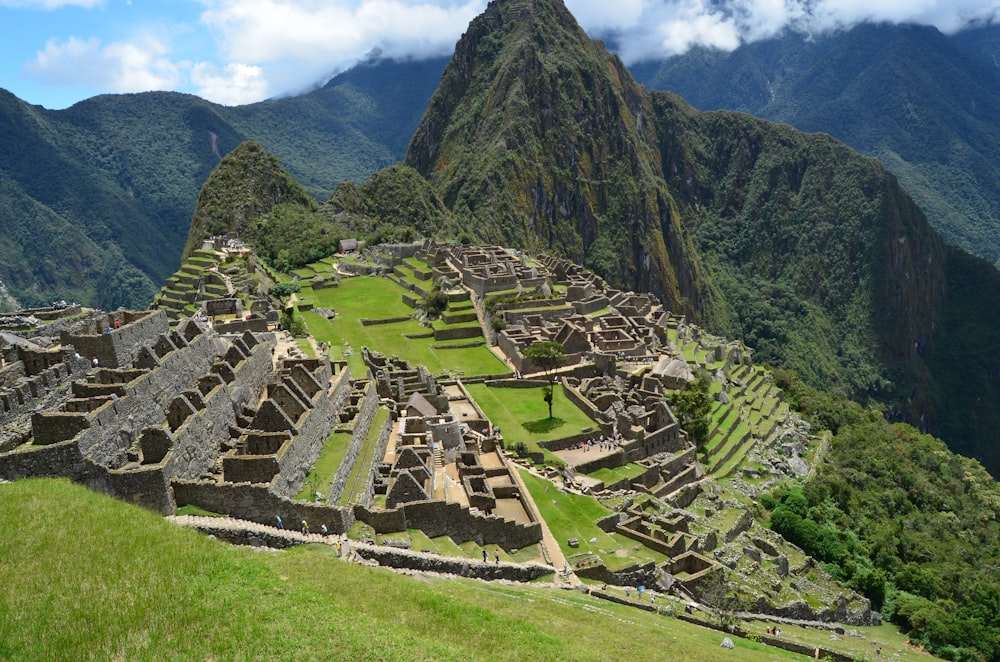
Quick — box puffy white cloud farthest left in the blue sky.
[24,37,182,92]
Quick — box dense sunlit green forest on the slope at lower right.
[776,373,1000,660]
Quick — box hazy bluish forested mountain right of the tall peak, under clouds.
[631,23,1000,264]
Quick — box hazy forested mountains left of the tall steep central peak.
[0,61,443,308]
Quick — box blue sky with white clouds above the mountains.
[0,0,1000,108]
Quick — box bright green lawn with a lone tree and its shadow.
[466,384,596,460]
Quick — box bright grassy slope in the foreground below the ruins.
[0,479,797,660]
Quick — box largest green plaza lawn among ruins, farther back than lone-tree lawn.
[300,276,500,377]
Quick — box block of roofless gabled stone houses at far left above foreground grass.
[0,311,273,512]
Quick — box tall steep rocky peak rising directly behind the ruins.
[406,0,701,314]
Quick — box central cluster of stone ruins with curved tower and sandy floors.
[355,348,541,549]
